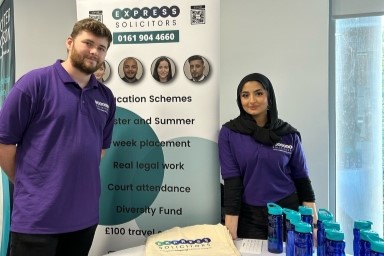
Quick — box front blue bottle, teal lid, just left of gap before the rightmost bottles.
[325,229,345,256]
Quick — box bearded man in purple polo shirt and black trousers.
[0,19,116,256]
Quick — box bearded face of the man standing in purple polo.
[67,31,108,75]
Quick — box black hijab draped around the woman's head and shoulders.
[224,73,300,145]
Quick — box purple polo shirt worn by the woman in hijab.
[218,126,308,206]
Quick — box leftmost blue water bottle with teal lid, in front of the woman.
[267,203,283,253]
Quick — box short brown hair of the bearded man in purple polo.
[71,18,112,48]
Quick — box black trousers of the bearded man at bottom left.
[10,225,97,256]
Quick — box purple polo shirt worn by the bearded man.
[0,60,116,234]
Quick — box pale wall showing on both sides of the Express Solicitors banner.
[14,0,329,208]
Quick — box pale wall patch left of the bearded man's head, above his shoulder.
[13,0,77,79]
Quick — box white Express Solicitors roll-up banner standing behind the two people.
[76,0,221,255]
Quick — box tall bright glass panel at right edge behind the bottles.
[335,17,383,254]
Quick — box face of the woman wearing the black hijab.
[240,81,268,122]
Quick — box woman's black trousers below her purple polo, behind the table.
[237,193,299,240]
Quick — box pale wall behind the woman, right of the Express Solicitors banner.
[220,0,329,208]
